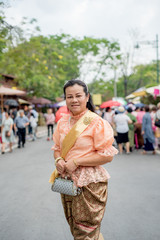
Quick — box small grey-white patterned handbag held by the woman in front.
[51,177,82,196]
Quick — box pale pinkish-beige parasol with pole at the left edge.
[0,86,26,111]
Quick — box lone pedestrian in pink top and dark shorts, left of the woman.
[44,108,55,141]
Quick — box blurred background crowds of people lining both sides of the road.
[1,100,160,154]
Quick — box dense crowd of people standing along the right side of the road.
[97,103,160,154]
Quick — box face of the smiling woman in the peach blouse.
[65,84,89,115]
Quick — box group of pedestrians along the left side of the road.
[0,105,55,154]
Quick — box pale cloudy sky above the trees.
[5,0,160,80]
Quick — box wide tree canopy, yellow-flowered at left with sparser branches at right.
[0,31,121,100]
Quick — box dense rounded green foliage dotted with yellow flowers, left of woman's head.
[0,36,79,100]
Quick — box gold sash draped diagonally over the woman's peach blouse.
[49,111,98,183]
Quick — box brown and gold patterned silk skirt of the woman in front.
[61,182,108,240]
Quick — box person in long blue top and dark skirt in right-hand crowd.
[142,106,156,154]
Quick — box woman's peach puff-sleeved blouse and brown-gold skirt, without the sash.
[52,110,118,240]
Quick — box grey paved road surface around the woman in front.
[0,138,160,240]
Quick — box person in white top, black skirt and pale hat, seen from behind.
[114,106,132,154]
